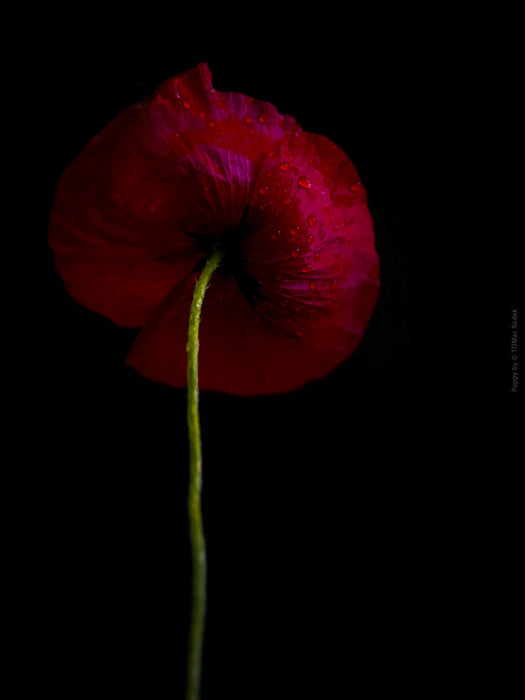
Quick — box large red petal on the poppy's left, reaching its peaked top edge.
[49,64,299,326]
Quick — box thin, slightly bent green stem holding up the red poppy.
[186,249,223,700]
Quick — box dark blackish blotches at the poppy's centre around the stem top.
[185,208,264,306]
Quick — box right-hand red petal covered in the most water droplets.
[244,133,379,350]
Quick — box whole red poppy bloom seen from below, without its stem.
[49,64,379,395]
